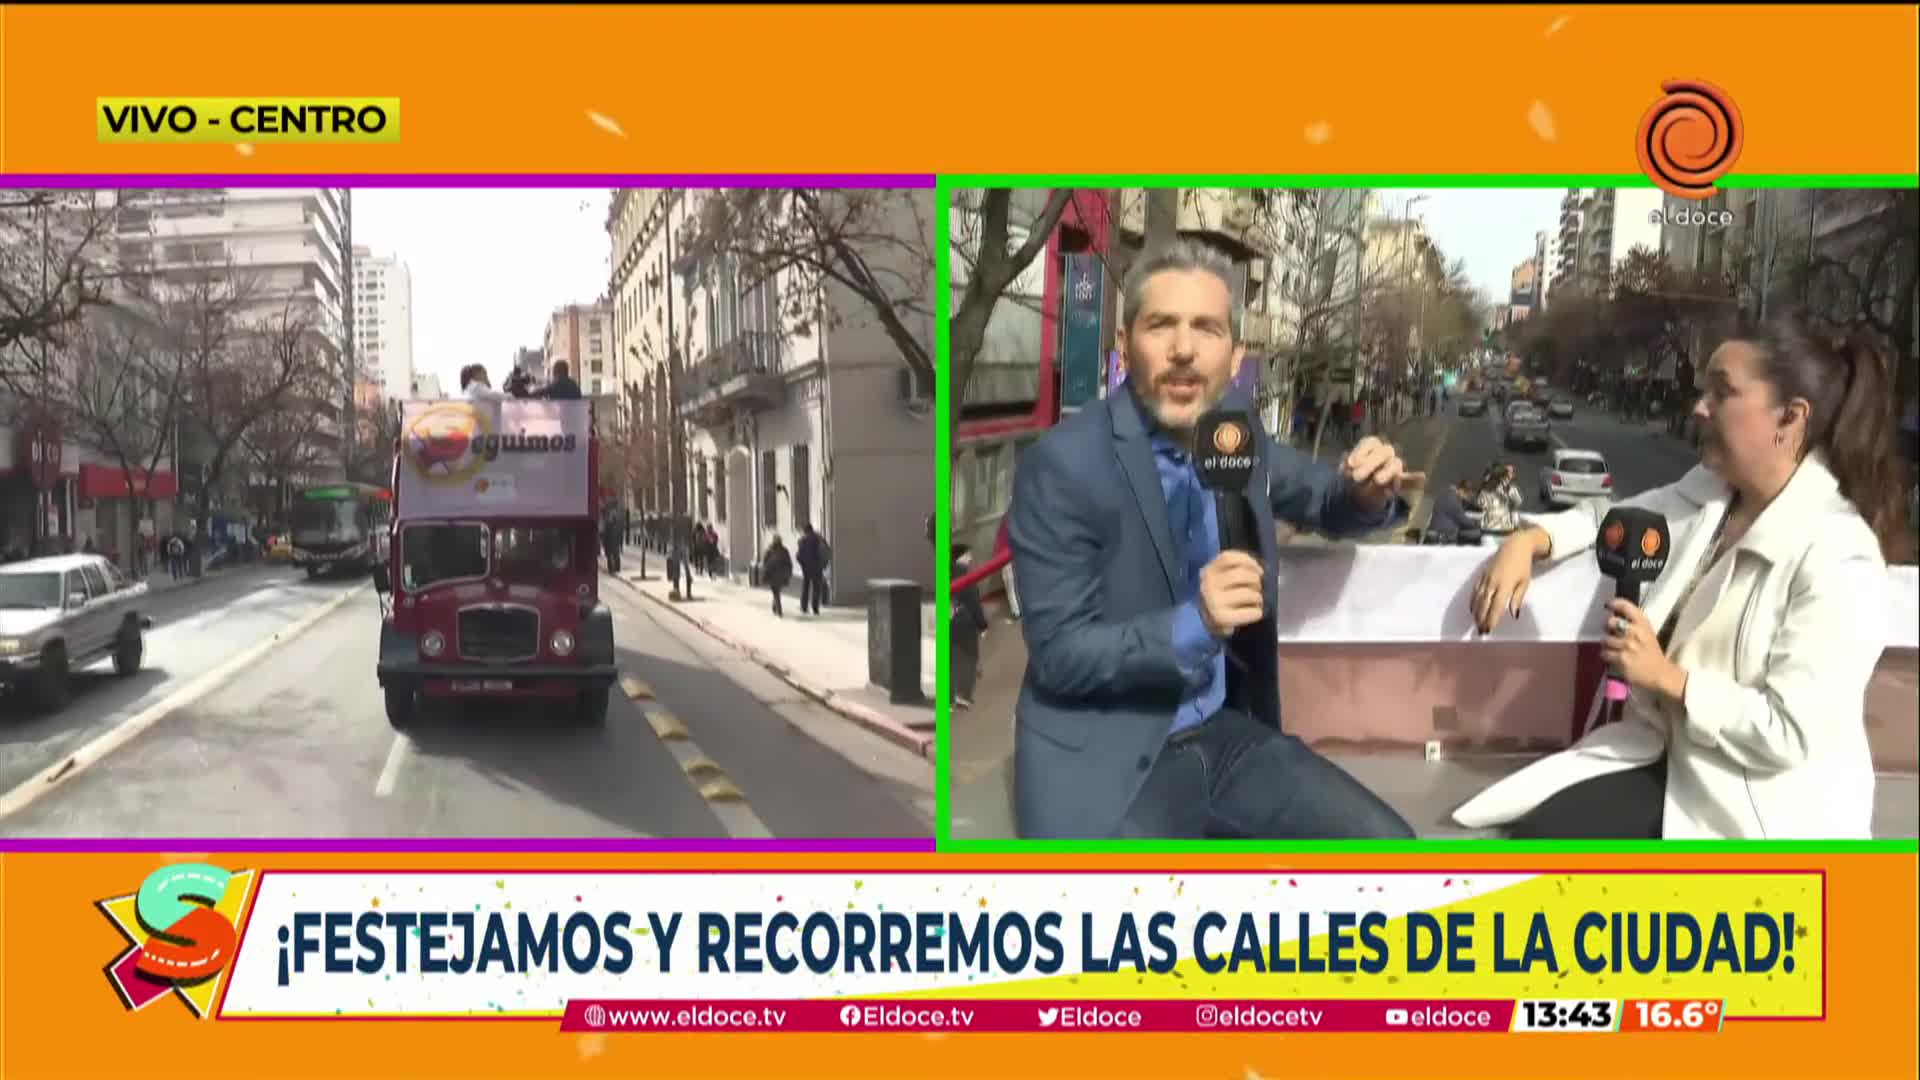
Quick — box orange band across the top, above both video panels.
[0,4,1920,175]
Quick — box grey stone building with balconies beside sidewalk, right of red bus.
[676,192,935,603]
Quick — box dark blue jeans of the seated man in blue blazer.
[1119,709,1415,840]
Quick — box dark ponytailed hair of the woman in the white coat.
[1736,319,1907,561]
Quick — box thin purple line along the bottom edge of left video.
[0,836,933,855]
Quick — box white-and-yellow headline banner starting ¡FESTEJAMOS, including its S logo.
[100,863,1826,1030]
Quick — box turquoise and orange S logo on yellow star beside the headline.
[98,863,253,1017]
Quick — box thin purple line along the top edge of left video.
[0,173,933,188]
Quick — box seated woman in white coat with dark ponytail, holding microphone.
[1453,323,1903,840]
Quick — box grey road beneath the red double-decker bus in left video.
[0,569,933,838]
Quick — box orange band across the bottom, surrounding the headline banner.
[0,851,1920,1080]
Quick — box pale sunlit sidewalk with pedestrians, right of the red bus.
[620,548,935,759]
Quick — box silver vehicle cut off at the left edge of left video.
[0,555,154,711]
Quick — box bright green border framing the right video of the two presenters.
[933,173,1920,855]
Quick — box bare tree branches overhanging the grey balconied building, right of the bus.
[682,188,935,386]
